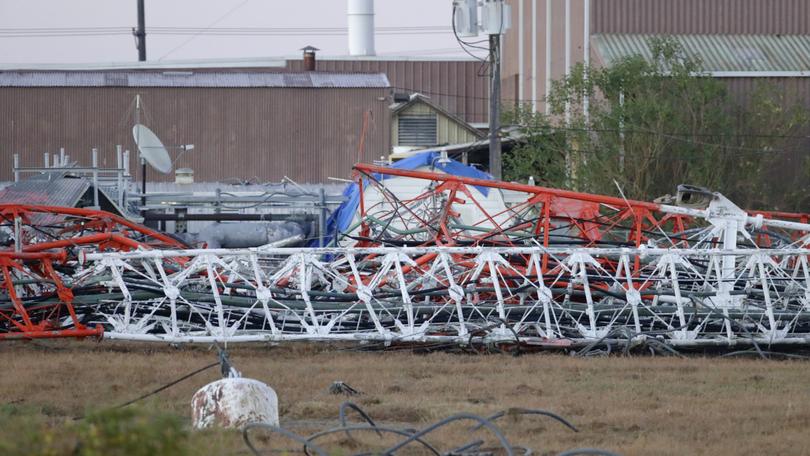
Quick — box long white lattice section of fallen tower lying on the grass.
[79,247,810,345]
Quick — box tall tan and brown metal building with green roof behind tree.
[502,0,810,112]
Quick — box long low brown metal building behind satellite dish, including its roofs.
[0,56,488,183]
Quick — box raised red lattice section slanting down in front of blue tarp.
[355,164,689,255]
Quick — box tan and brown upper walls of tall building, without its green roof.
[502,0,810,111]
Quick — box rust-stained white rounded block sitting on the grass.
[191,378,278,429]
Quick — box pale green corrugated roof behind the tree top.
[593,34,810,72]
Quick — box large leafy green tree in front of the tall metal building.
[504,38,808,207]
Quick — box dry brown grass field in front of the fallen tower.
[0,341,810,455]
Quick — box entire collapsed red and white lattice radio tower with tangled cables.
[0,165,810,349]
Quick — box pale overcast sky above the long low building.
[0,0,480,63]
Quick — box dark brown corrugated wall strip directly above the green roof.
[591,0,810,35]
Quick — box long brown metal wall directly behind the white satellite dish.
[0,87,391,183]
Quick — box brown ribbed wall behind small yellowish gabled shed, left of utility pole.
[287,59,489,122]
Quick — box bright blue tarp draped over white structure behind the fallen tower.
[310,151,492,247]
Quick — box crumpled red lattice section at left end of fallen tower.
[0,204,185,340]
